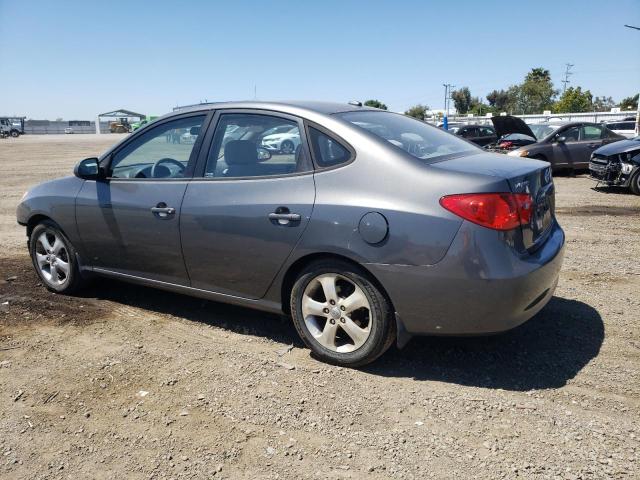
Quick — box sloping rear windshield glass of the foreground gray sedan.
[337,111,478,160]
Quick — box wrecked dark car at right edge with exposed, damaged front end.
[589,136,640,195]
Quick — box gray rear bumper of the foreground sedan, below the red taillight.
[366,221,564,335]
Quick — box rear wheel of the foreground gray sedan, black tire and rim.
[291,260,396,367]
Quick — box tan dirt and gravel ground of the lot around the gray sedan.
[0,135,640,479]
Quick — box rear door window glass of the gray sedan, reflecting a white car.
[204,113,309,178]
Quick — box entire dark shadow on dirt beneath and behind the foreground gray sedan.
[85,279,604,391]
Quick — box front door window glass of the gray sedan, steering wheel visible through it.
[110,115,205,179]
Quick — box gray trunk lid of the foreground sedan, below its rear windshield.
[432,154,555,251]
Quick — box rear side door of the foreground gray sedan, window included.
[180,110,315,299]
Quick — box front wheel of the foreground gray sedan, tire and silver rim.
[29,220,85,294]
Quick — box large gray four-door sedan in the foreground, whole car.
[17,102,564,367]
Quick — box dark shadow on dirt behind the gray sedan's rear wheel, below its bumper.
[365,297,604,391]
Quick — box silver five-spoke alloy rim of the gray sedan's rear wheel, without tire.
[301,273,372,353]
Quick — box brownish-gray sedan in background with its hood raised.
[494,117,625,171]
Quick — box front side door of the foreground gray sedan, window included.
[76,113,207,285]
